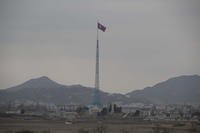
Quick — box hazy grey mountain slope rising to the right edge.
[126,75,200,104]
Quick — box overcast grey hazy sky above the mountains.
[0,0,200,93]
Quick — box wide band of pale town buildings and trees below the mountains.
[0,102,200,121]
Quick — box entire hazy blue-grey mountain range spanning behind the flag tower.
[0,75,200,104]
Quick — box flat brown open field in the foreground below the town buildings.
[0,117,200,133]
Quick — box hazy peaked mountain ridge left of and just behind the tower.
[0,76,126,104]
